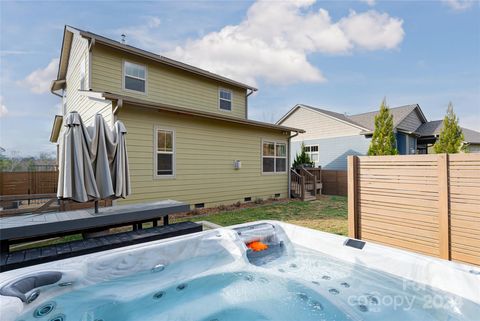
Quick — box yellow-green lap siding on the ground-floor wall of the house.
[118,105,288,207]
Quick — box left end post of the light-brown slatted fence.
[348,156,360,238]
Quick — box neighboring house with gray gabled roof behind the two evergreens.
[277,104,480,170]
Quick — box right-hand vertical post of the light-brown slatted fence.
[437,154,450,260]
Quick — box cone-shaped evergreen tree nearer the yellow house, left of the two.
[368,99,398,156]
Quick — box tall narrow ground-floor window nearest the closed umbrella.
[155,129,175,177]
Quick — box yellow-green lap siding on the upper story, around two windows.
[91,45,246,118]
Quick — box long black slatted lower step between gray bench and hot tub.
[0,222,202,272]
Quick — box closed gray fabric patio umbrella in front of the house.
[57,112,131,202]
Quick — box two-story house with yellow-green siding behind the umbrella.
[51,26,302,208]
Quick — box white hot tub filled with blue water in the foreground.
[0,221,480,321]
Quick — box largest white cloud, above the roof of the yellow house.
[166,0,404,84]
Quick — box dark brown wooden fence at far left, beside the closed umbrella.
[0,171,58,195]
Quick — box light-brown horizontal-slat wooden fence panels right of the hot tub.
[348,154,480,265]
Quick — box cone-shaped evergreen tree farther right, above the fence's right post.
[433,102,465,154]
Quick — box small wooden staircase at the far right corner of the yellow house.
[290,167,322,201]
